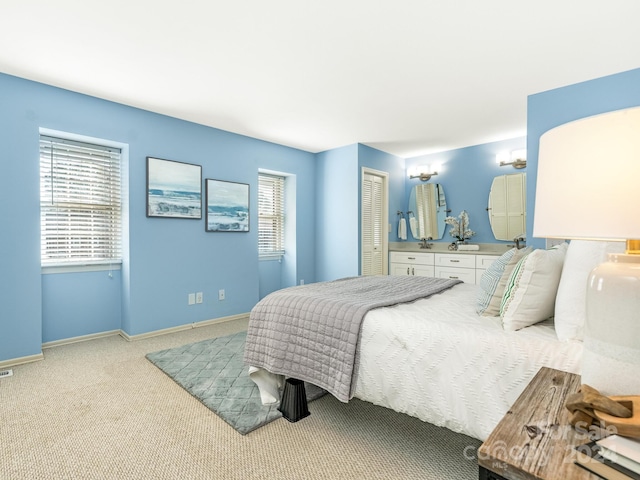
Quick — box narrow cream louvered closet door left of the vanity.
[362,173,385,275]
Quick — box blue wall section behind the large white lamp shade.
[527,68,640,248]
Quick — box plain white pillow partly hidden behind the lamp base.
[554,240,625,341]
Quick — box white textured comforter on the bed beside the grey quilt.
[355,284,582,440]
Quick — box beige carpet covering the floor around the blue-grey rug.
[0,320,480,480]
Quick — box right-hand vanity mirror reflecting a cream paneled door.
[487,173,527,240]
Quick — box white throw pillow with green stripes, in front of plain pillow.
[500,243,568,330]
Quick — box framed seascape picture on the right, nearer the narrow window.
[205,178,249,232]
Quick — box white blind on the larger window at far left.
[40,135,122,266]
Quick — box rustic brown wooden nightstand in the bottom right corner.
[478,368,599,480]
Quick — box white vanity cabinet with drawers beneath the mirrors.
[389,251,500,284]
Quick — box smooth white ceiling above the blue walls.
[0,0,640,157]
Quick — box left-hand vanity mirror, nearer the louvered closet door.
[409,183,447,240]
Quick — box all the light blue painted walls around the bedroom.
[0,69,640,361]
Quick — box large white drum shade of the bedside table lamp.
[533,107,640,240]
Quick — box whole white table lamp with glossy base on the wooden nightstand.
[533,107,640,395]
